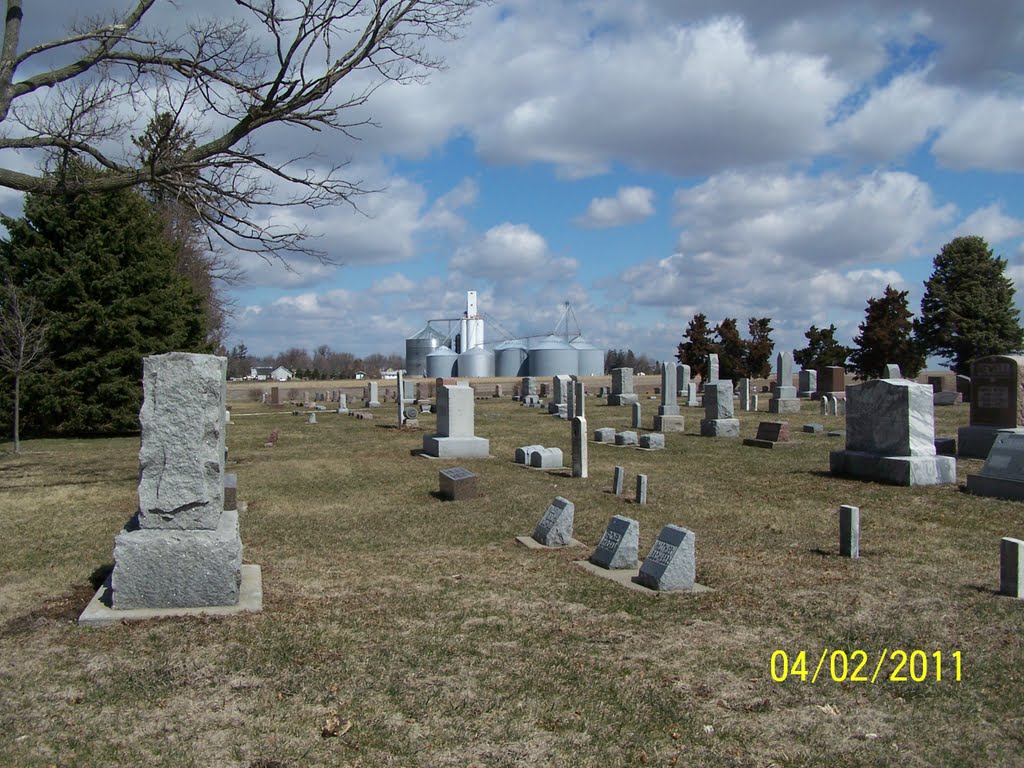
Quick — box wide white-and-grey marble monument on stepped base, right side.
[828,379,956,485]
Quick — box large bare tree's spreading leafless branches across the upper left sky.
[0,0,487,258]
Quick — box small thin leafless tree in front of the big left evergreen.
[0,282,46,454]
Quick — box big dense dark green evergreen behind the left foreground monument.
[0,177,208,433]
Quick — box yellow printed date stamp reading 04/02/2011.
[770,648,964,685]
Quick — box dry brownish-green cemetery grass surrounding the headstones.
[0,386,1024,768]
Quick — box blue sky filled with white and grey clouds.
[5,0,1024,359]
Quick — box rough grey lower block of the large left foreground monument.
[111,510,242,610]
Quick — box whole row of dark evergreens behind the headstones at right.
[676,236,1024,379]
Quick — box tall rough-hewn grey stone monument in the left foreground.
[111,352,242,610]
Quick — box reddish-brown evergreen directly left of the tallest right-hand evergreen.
[850,286,925,379]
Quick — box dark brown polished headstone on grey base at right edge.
[956,354,1024,459]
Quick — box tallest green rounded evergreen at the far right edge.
[914,236,1024,374]
